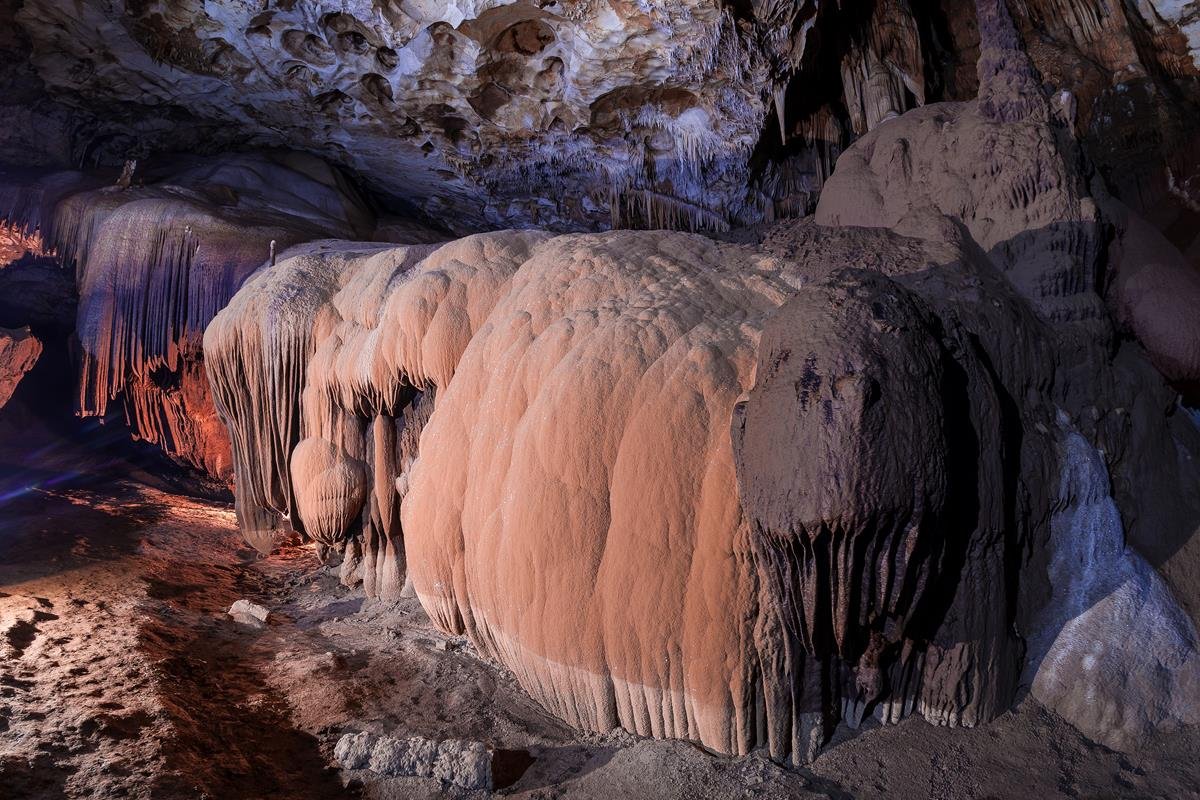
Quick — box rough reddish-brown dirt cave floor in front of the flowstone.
[0,459,1200,800]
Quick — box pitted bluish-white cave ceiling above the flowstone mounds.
[0,0,1200,239]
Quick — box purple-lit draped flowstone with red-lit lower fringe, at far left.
[0,152,376,480]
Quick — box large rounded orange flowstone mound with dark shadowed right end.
[205,224,1051,763]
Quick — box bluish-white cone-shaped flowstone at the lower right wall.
[1030,431,1200,751]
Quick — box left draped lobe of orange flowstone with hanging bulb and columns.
[204,233,545,556]
